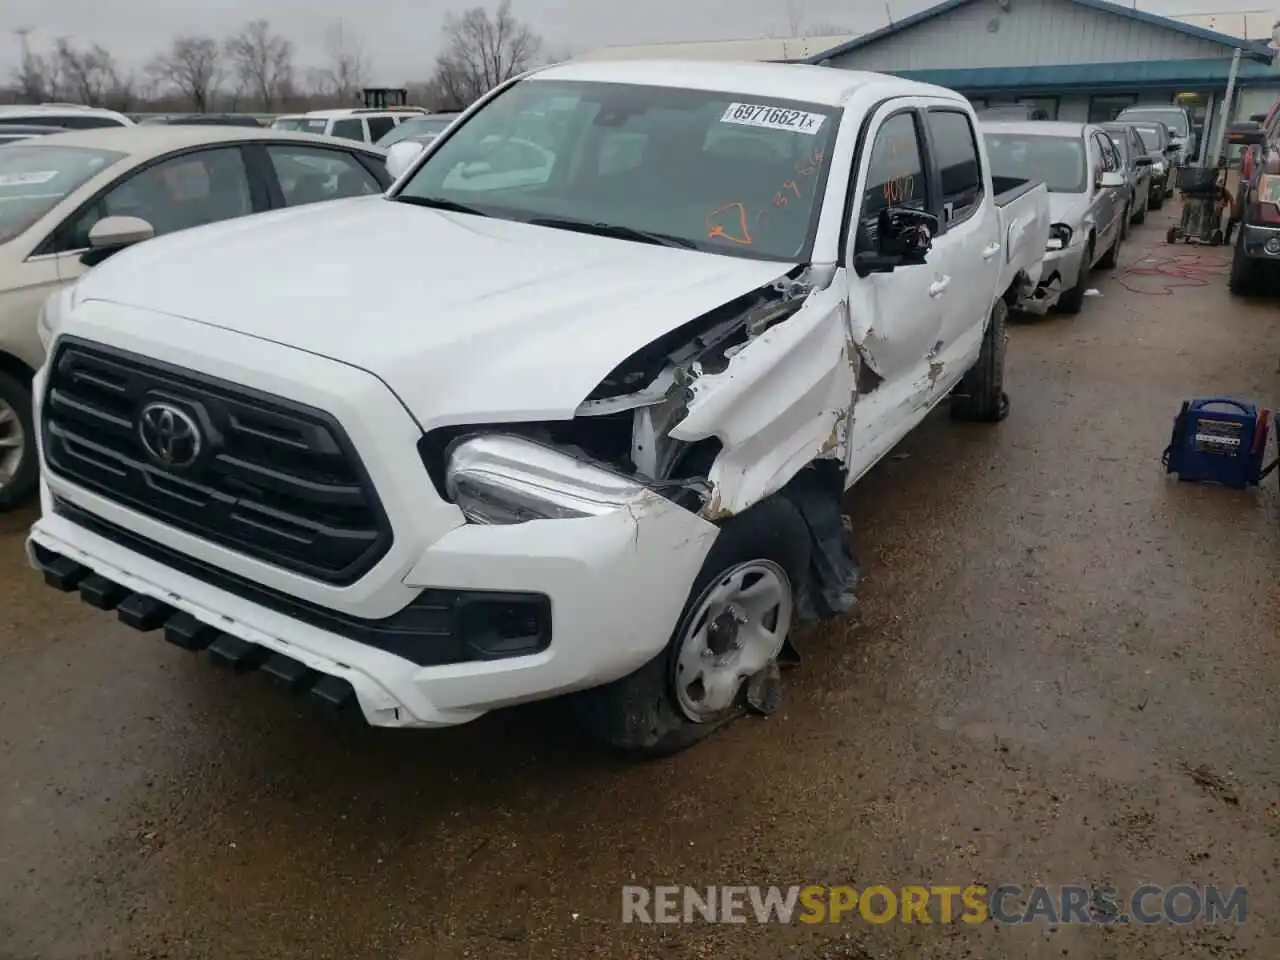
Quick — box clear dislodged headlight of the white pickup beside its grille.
[444,434,648,524]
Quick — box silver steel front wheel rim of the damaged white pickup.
[673,559,794,723]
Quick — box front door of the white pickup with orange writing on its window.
[846,108,950,394]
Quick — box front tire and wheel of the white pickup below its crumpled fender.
[572,494,809,758]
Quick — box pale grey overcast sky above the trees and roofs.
[0,0,1264,83]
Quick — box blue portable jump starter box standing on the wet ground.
[1161,397,1280,490]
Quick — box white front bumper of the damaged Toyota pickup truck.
[27,483,717,727]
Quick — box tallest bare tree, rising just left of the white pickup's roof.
[433,0,543,109]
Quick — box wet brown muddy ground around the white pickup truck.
[0,207,1280,960]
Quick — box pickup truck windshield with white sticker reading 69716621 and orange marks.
[396,78,840,261]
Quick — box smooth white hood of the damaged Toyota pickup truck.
[79,197,795,428]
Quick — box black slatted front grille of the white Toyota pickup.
[41,338,392,586]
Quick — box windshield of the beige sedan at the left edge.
[0,141,125,243]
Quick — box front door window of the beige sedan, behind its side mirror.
[58,147,253,251]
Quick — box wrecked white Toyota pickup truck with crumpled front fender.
[28,61,1048,754]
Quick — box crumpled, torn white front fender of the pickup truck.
[577,268,858,520]
